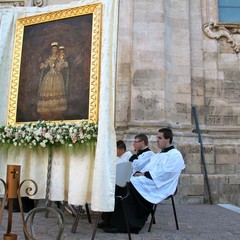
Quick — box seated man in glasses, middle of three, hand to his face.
[129,133,154,173]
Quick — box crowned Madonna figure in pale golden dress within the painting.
[37,42,68,120]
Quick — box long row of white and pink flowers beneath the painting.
[0,121,98,148]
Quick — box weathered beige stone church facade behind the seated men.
[0,0,240,206]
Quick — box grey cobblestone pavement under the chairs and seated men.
[0,204,240,240]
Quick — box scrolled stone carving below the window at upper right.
[203,22,240,53]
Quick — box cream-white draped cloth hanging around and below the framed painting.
[0,0,118,211]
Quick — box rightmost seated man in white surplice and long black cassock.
[99,128,185,233]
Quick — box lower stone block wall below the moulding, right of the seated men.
[179,144,240,205]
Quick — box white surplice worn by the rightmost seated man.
[130,149,185,204]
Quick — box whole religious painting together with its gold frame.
[8,3,102,125]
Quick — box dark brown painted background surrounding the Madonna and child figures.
[16,14,92,122]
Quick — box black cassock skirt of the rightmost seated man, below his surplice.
[102,183,153,233]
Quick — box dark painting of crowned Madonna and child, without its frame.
[16,14,92,122]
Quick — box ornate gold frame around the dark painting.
[7,3,102,125]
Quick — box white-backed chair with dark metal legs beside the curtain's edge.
[91,162,132,240]
